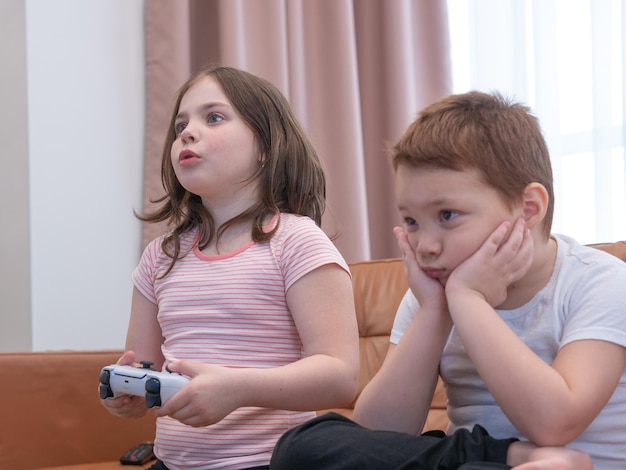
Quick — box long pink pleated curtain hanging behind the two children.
[144,0,451,262]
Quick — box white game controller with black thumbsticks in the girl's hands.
[99,361,189,408]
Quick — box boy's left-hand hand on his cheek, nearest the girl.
[393,227,447,310]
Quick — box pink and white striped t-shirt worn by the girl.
[133,214,349,470]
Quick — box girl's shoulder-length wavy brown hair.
[137,67,326,276]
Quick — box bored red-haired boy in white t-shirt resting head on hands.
[274,92,626,470]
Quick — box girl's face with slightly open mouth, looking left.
[171,77,261,207]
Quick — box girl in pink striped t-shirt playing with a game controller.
[103,67,358,470]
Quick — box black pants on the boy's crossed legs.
[270,413,517,470]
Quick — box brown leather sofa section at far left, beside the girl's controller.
[0,351,155,470]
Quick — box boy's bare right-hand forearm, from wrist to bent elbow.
[449,295,584,445]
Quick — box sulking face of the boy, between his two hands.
[395,165,522,286]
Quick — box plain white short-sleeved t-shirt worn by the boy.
[391,235,626,470]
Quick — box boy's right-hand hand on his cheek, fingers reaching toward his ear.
[446,218,533,308]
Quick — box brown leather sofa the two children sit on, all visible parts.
[0,242,626,470]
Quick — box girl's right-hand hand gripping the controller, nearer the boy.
[155,360,241,427]
